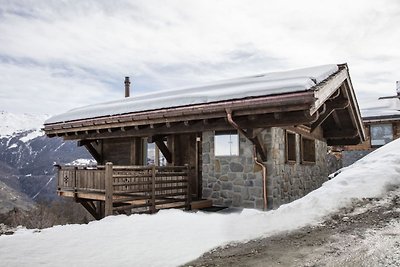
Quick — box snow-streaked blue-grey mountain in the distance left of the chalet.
[0,111,92,213]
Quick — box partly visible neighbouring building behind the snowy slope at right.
[340,81,400,167]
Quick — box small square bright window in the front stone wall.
[214,131,239,156]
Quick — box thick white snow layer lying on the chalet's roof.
[45,64,339,124]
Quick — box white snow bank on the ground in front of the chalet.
[0,139,400,266]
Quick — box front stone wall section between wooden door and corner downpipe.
[202,132,263,209]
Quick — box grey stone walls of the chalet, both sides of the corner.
[202,128,328,209]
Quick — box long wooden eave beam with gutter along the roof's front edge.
[44,92,315,137]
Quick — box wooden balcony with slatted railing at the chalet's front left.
[57,163,191,219]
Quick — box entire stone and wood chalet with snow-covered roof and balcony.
[44,64,364,218]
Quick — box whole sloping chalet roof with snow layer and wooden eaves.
[44,64,365,145]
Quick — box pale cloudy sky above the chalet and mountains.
[0,0,400,114]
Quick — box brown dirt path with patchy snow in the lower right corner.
[186,189,400,267]
